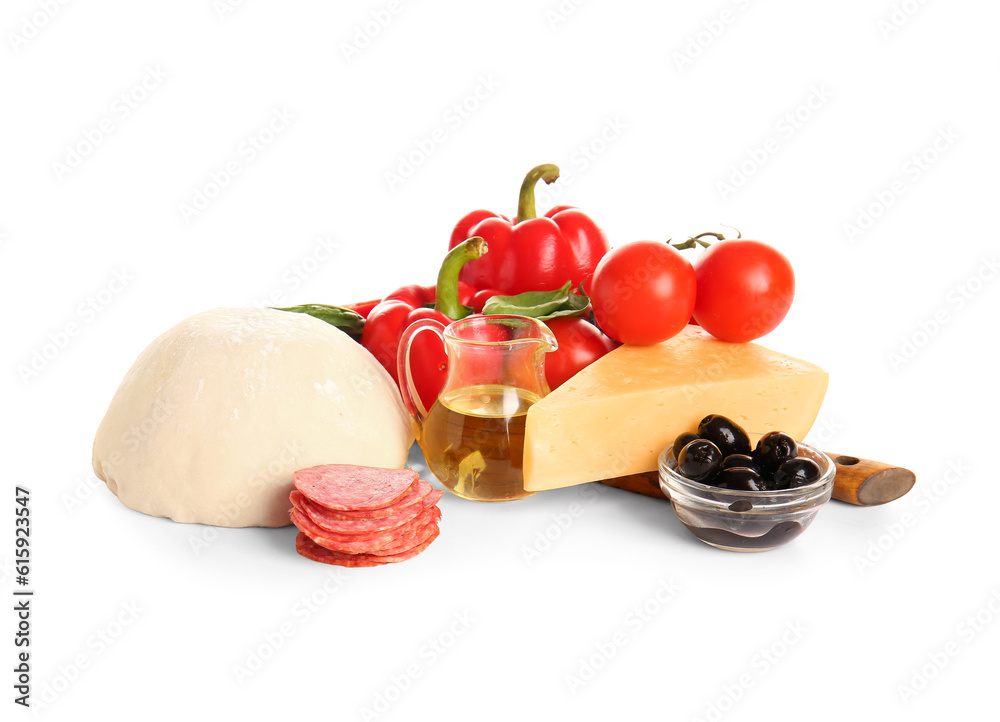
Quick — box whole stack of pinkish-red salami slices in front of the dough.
[291,464,444,567]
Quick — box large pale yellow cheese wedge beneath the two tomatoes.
[524,326,828,491]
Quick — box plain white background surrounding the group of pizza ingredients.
[0,0,1000,720]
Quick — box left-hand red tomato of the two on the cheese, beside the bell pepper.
[590,241,696,346]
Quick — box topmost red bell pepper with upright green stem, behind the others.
[448,163,610,295]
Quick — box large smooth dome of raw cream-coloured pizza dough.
[93,308,413,527]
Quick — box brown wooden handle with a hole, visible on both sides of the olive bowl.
[601,453,917,506]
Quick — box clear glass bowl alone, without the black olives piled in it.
[659,444,837,552]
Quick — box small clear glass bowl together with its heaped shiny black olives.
[659,415,837,552]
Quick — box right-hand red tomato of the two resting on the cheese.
[694,240,795,343]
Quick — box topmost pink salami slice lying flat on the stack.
[292,464,418,512]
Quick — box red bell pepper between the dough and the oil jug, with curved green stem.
[361,238,487,408]
